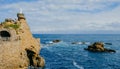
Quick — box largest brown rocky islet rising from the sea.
[85,42,116,52]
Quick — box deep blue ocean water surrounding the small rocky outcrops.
[34,34,120,69]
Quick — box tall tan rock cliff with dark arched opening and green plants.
[0,13,45,69]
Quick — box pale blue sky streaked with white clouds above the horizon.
[0,0,120,34]
